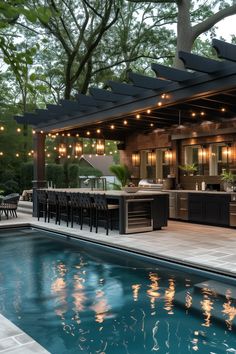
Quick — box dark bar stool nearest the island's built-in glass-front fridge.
[93,194,119,235]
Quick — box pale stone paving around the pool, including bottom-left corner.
[0,213,236,354]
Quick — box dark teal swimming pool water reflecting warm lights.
[0,229,236,354]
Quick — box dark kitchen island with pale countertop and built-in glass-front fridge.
[36,188,169,234]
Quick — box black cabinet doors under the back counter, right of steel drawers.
[188,193,230,226]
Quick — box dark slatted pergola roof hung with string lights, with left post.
[15,39,236,196]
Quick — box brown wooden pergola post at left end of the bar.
[32,132,47,216]
